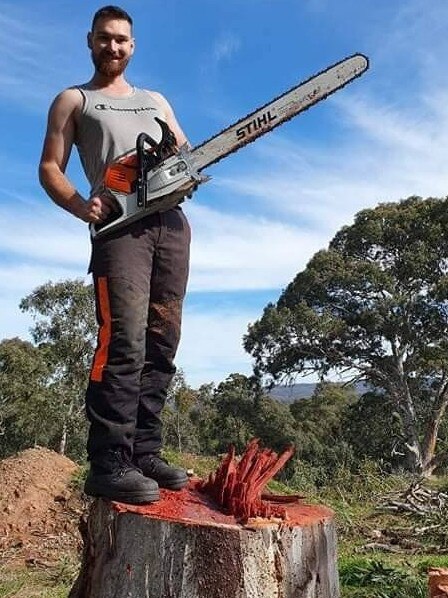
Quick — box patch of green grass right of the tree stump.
[315,464,448,598]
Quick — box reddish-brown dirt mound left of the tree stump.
[0,448,85,564]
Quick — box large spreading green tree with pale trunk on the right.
[245,197,448,475]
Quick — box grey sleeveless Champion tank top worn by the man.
[75,85,165,195]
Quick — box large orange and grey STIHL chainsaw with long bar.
[90,54,369,238]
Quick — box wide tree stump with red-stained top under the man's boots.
[69,440,339,598]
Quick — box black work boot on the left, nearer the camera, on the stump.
[84,448,160,504]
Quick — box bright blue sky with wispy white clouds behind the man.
[0,0,448,387]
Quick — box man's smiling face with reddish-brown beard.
[87,19,134,77]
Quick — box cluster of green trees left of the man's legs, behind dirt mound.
[0,281,96,460]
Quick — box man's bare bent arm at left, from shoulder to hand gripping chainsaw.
[39,89,113,222]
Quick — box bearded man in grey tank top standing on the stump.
[39,6,190,503]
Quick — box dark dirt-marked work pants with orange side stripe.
[86,207,190,460]
